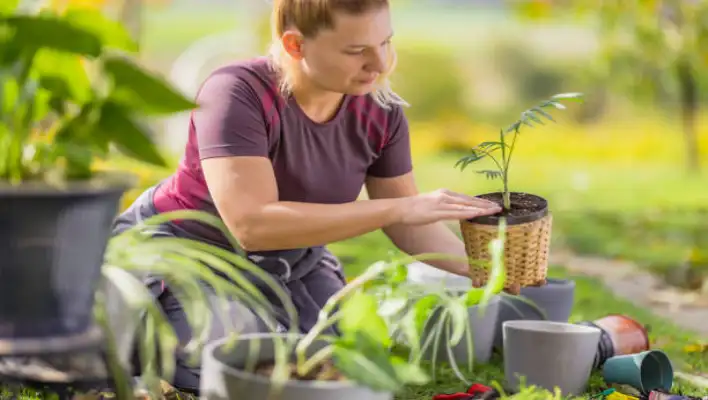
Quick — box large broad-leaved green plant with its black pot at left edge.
[0,1,195,339]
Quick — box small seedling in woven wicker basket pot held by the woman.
[455,93,582,294]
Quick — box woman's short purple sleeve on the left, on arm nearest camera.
[192,68,268,160]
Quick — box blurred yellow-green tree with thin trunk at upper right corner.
[512,0,708,171]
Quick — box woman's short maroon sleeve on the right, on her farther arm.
[368,106,413,178]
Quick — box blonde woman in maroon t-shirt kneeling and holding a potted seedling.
[116,0,500,388]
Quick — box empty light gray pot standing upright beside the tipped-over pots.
[503,321,601,396]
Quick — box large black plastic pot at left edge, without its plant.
[0,177,131,339]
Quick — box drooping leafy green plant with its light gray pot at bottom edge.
[200,222,505,400]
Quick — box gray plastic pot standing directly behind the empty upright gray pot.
[494,278,575,350]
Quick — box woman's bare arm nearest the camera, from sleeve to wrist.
[202,156,402,251]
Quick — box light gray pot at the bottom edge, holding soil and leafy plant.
[199,333,393,400]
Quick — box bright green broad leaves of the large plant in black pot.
[0,1,196,183]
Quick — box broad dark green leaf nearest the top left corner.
[5,15,101,57]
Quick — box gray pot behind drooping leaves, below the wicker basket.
[422,296,501,366]
